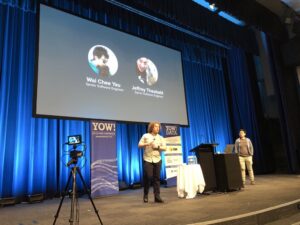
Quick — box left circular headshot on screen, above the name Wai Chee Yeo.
[88,45,118,77]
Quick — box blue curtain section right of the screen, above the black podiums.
[181,56,232,160]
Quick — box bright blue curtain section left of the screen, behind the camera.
[0,1,89,199]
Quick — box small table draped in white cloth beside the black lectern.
[177,164,205,199]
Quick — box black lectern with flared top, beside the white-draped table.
[190,143,218,192]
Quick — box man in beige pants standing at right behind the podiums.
[234,129,255,187]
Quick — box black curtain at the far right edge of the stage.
[264,37,300,173]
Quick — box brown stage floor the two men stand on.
[0,175,300,225]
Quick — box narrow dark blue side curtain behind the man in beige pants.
[227,48,267,172]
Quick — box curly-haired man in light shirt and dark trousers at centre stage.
[138,122,166,203]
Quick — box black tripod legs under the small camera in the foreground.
[53,164,103,225]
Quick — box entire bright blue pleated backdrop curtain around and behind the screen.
[0,0,262,198]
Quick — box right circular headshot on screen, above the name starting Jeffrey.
[136,57,158,86]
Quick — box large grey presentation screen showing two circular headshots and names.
[34,4,188,125]
